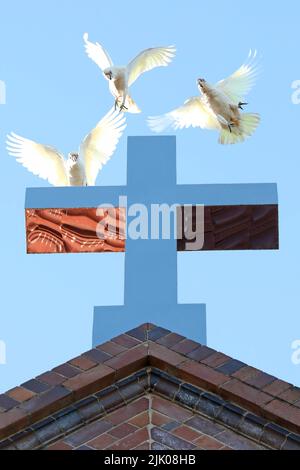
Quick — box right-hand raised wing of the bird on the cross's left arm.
[80,109,126,186]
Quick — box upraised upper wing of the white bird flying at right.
[216,51,259,104]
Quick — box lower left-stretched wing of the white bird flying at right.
[148,96,220,132]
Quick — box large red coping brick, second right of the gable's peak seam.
[178,360,228,391]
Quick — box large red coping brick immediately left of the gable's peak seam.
[105,344,148,379]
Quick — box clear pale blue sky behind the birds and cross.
[0,0,300,391]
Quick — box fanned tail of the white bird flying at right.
[219,113,260,145]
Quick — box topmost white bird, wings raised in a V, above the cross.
[83,33,176,113]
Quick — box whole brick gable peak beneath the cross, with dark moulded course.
[0,324,300,450]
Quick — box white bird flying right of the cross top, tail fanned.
[148,51,260,144]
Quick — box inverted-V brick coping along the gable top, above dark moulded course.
[0,323,300,439]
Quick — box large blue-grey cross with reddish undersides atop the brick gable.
[26,137,278,345]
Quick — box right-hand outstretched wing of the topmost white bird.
[127,46,176,86]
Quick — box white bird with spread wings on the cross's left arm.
[7,109,126,186]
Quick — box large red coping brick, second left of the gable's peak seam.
[64,364,115,400]
